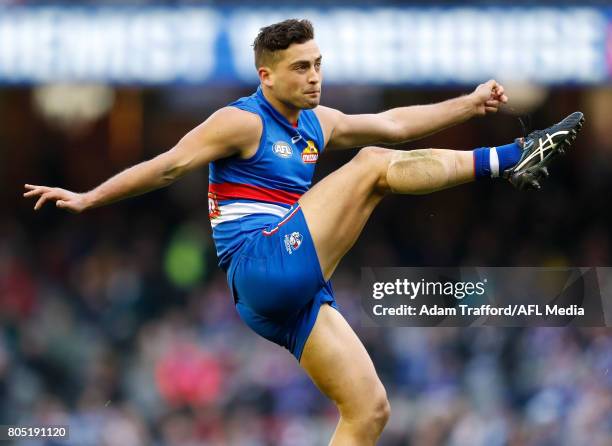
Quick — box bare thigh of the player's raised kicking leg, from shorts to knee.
[300,147,393,280]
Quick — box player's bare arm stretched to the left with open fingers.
[23,107,262,213]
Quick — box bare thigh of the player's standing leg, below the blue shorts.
[300,305,385,417]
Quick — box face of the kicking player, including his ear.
[260,40,322,109]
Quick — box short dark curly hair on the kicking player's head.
[253,19,314,68]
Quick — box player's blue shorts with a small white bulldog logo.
[227,203,338,361]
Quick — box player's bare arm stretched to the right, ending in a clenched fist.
[316,80,508,149]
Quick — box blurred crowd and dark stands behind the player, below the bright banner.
[0,82,612,446]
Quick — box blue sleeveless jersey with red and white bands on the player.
[208,87,324,270]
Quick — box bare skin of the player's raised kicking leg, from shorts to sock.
[300,147,474,279]
